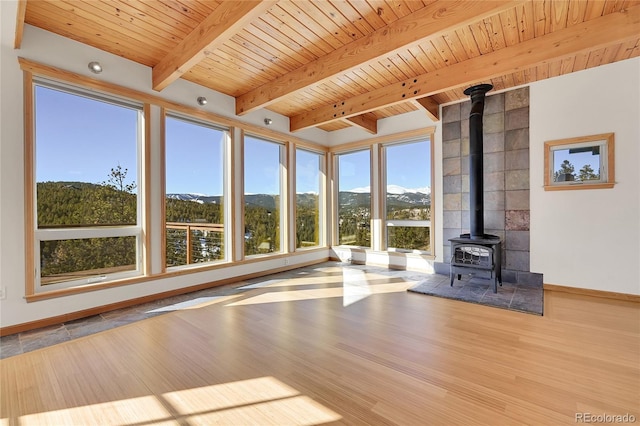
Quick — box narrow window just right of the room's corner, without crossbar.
[336,150,371,247]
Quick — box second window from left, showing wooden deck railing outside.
[165,116,229,267]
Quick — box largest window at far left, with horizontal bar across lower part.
[29,80,143,292]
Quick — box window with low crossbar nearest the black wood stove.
[383,140,431,252]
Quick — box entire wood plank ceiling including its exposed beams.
[16,0,640,133]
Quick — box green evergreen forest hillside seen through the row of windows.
[37,166,430,284]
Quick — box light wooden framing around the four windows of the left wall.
[18,57,340,303]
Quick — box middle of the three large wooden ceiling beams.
[236,0,523,115]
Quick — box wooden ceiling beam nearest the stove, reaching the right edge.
[289,6,640,132]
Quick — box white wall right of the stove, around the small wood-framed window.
[530,58,640,295]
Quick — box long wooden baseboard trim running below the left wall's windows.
[0,257,329,337]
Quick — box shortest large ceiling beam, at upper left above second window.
[152,0,277,91]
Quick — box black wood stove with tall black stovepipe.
[449,84,502,293]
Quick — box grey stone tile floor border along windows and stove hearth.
[0,262,542,359]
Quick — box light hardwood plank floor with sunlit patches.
[0,264,640,426]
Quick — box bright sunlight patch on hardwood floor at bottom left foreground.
[15,377,342,426]
